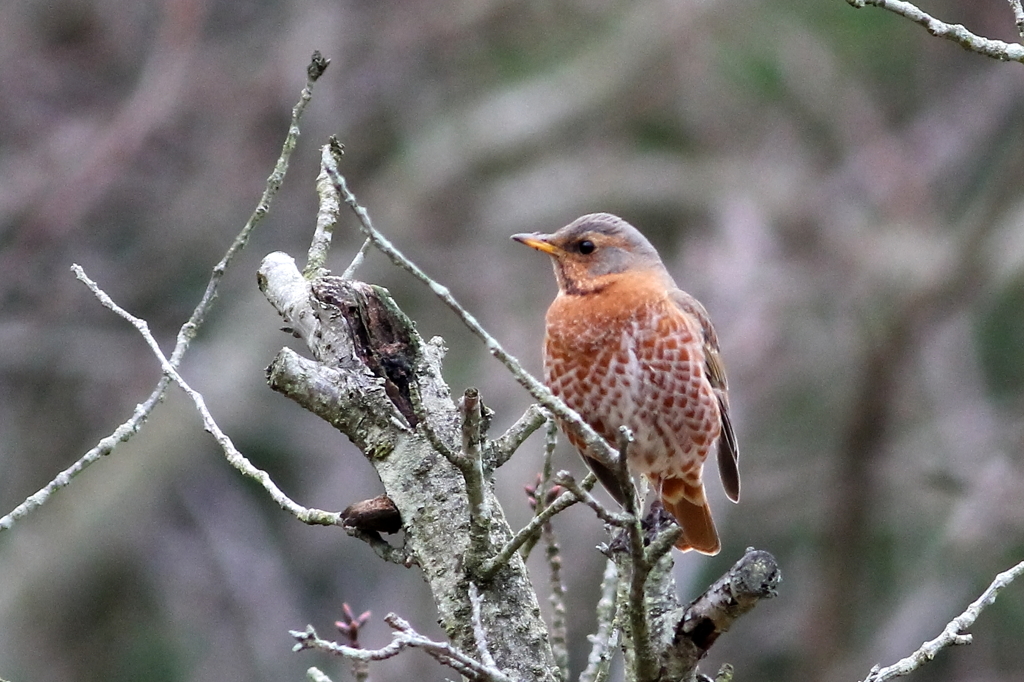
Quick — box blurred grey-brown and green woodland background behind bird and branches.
[0,0,1024,682]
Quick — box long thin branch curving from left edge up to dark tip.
[0,52,327,532]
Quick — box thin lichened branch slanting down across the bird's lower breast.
[325,155,615,471]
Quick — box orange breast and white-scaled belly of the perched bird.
[544,270,722,485]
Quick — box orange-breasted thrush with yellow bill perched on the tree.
[512,213,739,555]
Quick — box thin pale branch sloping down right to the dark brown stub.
[72,265,344,525]
